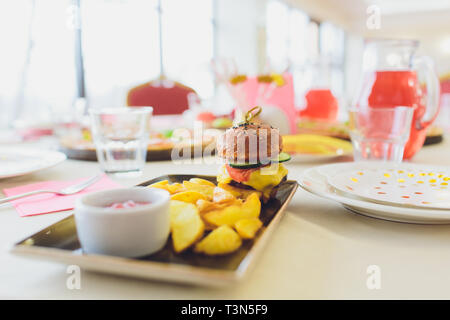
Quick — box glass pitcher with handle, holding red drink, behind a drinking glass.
[355,40,439,159]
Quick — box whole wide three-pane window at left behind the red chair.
[0,0,215,127]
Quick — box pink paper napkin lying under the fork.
[3,174,121,217]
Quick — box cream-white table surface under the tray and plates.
[0,141,450,299]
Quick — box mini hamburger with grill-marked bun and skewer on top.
[217,107,290,202]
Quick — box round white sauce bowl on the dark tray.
[75,187,170,258]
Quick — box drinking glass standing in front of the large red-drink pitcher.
[349,106,414,163]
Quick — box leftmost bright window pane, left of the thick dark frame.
[0,0,76,127]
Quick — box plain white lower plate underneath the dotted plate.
[298,162,450,224]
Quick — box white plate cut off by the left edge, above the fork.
[0,147,66,179]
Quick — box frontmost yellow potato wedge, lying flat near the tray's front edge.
[194,225,242,255]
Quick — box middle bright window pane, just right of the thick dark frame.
[81,0,160,107]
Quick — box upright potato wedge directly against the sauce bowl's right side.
[170,200,205,252]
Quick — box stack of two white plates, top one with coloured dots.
[299,162,450,224]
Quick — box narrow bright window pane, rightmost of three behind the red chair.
[161,0,214,97]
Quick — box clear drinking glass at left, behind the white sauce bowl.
[89,107,153,176]
